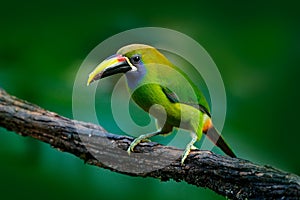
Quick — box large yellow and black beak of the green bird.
[87,54,136,85]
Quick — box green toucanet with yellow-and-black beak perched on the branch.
[87,44,236,164]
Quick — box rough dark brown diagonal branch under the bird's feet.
[0,88,300,199]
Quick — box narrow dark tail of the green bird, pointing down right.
[205,126,236,158]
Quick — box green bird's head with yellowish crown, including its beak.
[87,44,171,85]
